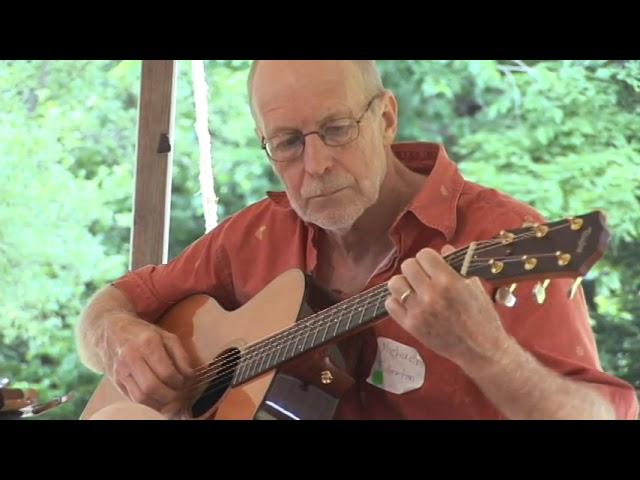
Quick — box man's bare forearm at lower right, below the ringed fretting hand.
[464,338,615,419]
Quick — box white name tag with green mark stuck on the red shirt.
[367,337,426,393]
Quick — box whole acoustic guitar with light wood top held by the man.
[81,211,610,420]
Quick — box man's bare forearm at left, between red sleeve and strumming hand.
[76,286,136,373]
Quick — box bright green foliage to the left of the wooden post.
[0,61,139,418]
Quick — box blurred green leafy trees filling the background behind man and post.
[0,60,640,419]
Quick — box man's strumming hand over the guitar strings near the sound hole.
[101,314,193,413]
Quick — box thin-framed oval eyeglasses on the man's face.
[262,92,384,163]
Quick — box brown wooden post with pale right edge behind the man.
[130,60,177,270]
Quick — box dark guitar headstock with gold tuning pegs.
[445,211,610,306]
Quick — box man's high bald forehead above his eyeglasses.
[253,61,364,132]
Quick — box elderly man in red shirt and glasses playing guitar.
[78,61,638,419]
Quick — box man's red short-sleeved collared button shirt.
[114,143,638,419]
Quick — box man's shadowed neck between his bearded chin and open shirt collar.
[326,151,425,258]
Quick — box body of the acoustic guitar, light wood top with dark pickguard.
[80,270,353,420]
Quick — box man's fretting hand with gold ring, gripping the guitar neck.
[385,245,510,369]
